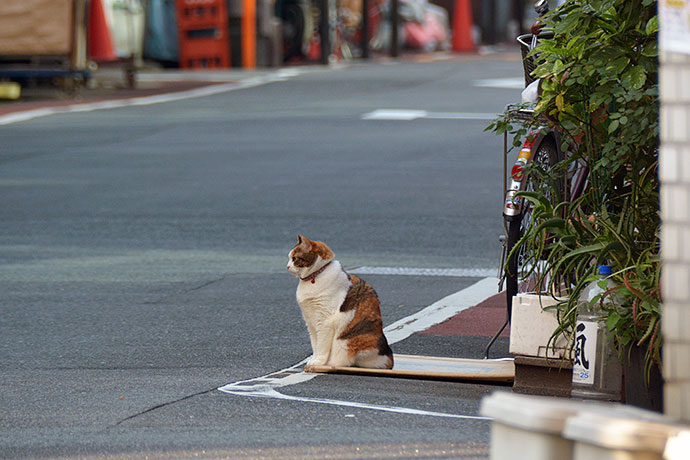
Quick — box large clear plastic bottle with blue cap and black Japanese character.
[570,265,623,401]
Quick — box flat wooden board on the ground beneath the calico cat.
[312,355,515,383]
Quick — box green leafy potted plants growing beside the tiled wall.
[487,0,661,374]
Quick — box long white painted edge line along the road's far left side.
[0,71,300,125]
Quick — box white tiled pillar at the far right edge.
[659,48,690,422]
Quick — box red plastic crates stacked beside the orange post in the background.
[177,0,230,69]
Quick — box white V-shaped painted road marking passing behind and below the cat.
[218,277,498,420]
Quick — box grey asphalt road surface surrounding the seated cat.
[0,55,521,458]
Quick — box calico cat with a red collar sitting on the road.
[287,235,393,372]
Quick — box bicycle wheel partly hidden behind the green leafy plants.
[505,137,563,313]
